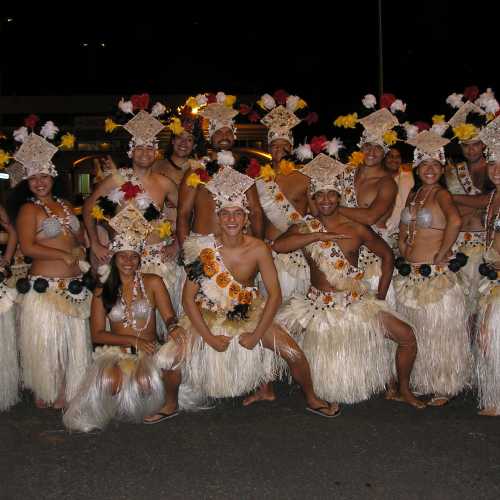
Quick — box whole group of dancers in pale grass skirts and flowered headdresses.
[0,89,500,432]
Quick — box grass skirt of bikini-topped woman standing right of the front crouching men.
[394,265,472,397]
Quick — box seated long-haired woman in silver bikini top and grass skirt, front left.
[64,233,188,432]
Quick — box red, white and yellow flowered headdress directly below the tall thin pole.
[333,94,411,153]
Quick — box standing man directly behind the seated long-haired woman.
[83,96,180,316]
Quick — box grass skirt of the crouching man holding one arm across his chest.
[276,287,393,403]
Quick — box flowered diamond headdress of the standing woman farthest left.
[0,115,75,184]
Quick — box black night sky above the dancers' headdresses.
[0,0,500,134]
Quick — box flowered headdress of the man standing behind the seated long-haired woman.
[104,94,167,158]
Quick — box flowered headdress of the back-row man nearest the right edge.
[446,86,500,144]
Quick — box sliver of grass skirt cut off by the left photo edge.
[0,283,19,411]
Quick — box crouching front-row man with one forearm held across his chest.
[273,155,425,408]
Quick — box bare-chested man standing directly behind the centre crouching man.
[177,103,263,247]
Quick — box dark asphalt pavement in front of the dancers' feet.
[0,384,500,500]
